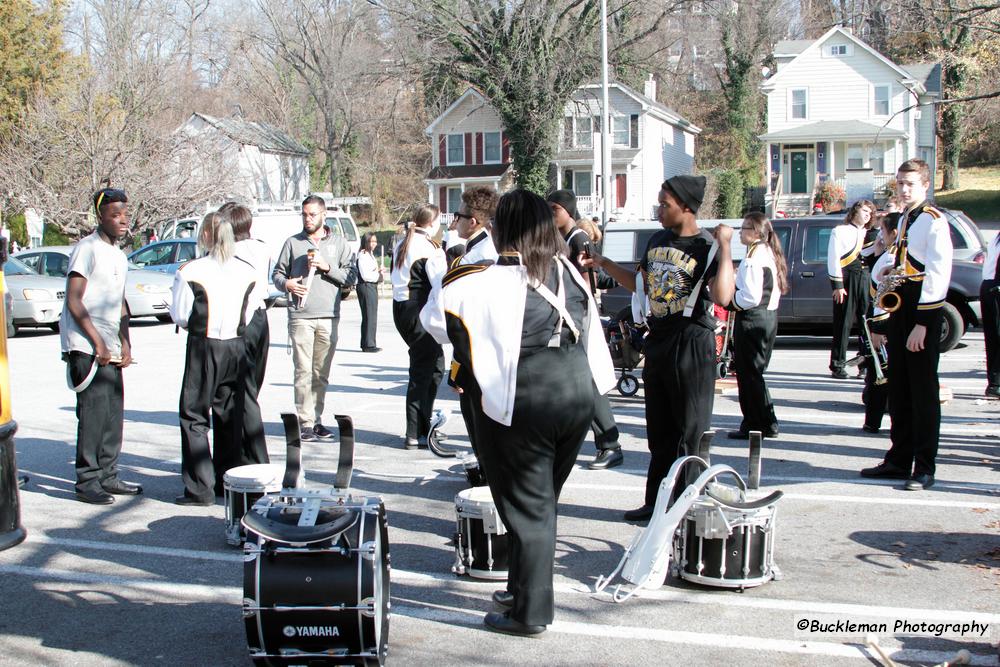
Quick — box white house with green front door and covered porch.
[761,27,941,212]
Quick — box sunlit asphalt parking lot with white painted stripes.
[0,299,1000,667]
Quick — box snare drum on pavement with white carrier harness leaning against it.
[674,499,775,589]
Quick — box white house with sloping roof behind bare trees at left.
[176,112,309,205]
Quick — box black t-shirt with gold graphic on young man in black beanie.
[639,229,718,334]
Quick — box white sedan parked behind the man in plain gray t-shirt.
[14,246,174,322]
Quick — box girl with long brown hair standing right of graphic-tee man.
[729,213,788,440]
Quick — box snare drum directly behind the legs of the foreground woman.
[451,486,508,579]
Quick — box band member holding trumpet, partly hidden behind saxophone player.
[861,213,899,433]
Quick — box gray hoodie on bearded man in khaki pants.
[272,228,357,319]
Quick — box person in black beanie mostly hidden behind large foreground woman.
[546,190,625,470]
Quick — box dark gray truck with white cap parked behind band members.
[602,215,982,351]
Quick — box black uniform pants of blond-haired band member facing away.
[180,335,246,500]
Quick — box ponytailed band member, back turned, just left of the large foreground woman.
[390,204,448,449]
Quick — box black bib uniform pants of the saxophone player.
[885,282,942,475]
